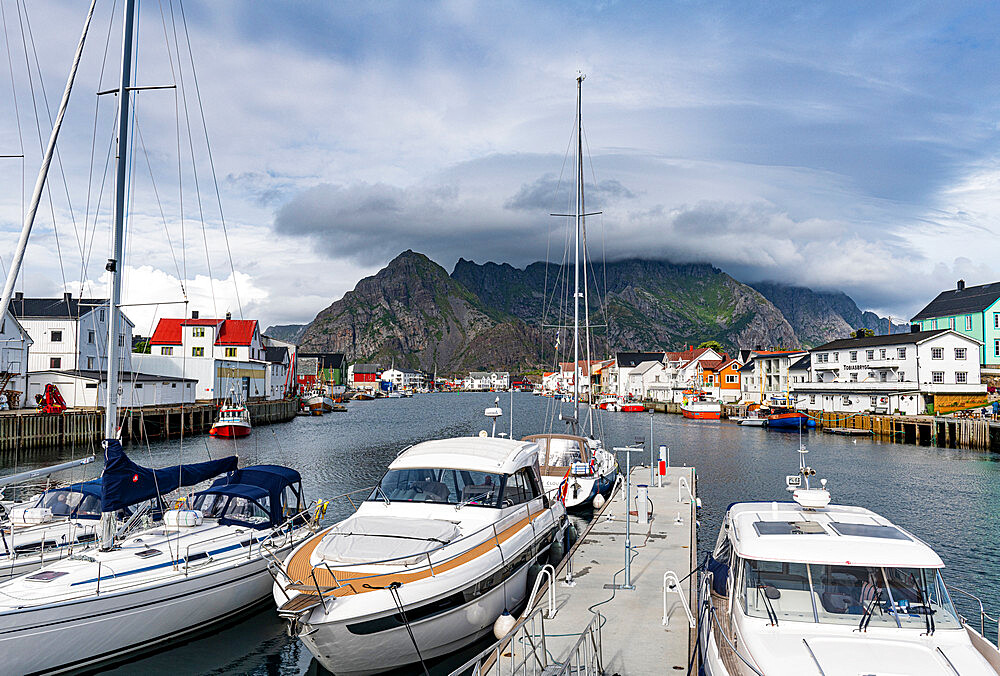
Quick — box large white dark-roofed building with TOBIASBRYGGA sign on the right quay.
[791,329,986,415]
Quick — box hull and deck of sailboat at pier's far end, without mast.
[524,434,618,509]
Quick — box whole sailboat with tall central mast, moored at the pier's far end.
[525,73,618,509]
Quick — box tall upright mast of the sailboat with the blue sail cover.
[101,0,135,549]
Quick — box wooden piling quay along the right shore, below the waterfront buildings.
[646,402,1000,452]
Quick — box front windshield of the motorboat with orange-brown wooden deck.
[368,468,503,507]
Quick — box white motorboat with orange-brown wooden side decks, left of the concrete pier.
[274,437,566,675]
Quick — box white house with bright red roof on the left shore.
[143,312,268,401]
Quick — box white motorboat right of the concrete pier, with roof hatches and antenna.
[698,449,1000,676]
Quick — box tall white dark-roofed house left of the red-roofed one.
[10,293,135,371]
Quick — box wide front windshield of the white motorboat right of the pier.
[740,560,962,629]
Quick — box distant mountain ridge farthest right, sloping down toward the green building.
[751,282,909,347]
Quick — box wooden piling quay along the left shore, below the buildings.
[0,399,298,456]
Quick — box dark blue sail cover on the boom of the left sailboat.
[101,439,238,512]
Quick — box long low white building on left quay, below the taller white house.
[28,370,198,408]
